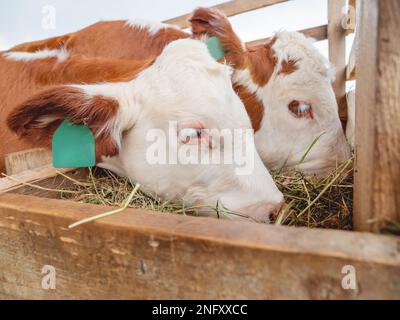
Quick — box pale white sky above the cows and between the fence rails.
[0,0,351,62]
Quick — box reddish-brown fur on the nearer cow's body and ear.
[0,54,152,172]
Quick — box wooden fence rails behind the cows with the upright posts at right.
[166,0,400,232]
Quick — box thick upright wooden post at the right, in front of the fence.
[354,0,400,232]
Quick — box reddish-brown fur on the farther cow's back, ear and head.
[7,8,284,145]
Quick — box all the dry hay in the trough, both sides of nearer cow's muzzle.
[57,160,353,230]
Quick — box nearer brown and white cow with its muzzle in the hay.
[0,39,283,222]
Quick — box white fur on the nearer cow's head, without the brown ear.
[50,39,283,221]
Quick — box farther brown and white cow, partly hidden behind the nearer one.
[11,8,350,175]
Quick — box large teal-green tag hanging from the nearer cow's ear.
[52,120,96,168]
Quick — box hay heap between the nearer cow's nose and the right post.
[273,160,353,230]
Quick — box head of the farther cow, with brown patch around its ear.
[190,8,350,174]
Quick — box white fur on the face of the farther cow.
[233,32,350,174]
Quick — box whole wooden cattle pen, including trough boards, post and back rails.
[0,0,400,299]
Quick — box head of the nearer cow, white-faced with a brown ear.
[8,40,283,221]
